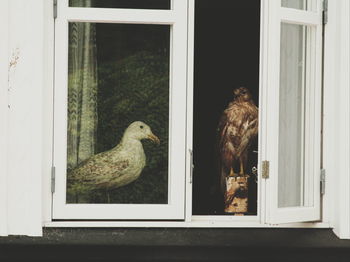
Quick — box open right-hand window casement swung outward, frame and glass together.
[264,1,322,224]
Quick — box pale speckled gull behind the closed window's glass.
[67,121,159,202]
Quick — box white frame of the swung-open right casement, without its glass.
[263,1,323,224]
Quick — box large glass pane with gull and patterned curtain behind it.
[67,22,170,204]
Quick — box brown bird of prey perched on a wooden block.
[218,87,258,192]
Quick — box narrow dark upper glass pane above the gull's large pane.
[69,0,171,9]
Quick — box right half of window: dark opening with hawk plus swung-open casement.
[192,1,323,224]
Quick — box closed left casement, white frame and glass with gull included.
[53,0,187,220]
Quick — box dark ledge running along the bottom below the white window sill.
[0,228,350,262]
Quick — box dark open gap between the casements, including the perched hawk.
[191,0,261,217]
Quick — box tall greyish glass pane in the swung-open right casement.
[278,23,306,207]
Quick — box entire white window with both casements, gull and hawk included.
[52,0,323,226]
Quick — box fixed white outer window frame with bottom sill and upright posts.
[39,0,330,228]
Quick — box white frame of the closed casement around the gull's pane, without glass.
[52,0,187,220]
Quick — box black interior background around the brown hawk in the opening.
[193,0,260,215]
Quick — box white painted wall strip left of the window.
[0,0,50,236]
